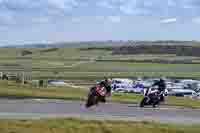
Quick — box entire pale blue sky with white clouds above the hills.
[0,0,200,45]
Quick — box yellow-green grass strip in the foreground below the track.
[0,119,200,133]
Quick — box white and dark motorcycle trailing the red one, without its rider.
[140,88,163,108]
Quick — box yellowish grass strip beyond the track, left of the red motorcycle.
[0,81,87,100]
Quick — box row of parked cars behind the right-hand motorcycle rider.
[112,78,200,97]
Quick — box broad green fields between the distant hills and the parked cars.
[0,48,200,79]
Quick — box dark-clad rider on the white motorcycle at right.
[152,77,166,102]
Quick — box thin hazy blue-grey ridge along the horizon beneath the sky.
[0,40,200,48]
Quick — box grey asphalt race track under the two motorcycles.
[0,99,200,124]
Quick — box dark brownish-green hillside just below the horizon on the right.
[112,44,200,57]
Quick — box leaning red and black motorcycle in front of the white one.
[85,85,107,108]
